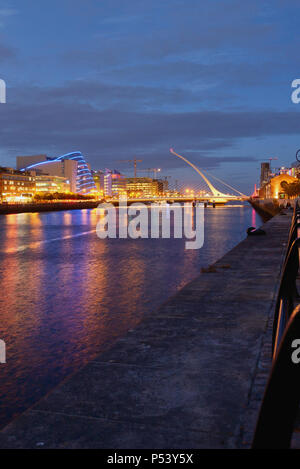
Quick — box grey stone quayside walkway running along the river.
[0,214,291,449]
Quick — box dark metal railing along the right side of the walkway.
[252,201,300,449]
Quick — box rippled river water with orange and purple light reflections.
[0,204,262,426]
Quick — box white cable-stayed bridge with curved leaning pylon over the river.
[113,148,249,206]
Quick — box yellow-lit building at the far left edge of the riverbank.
[0,167,35,202]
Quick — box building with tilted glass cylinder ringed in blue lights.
[17,152,96,194]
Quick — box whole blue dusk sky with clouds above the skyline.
[0,0,300,193]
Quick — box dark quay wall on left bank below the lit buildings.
[0,200,100,215]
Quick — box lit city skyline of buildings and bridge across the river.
[0,148,299,198]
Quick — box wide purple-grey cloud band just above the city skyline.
[0,79,299,168]
